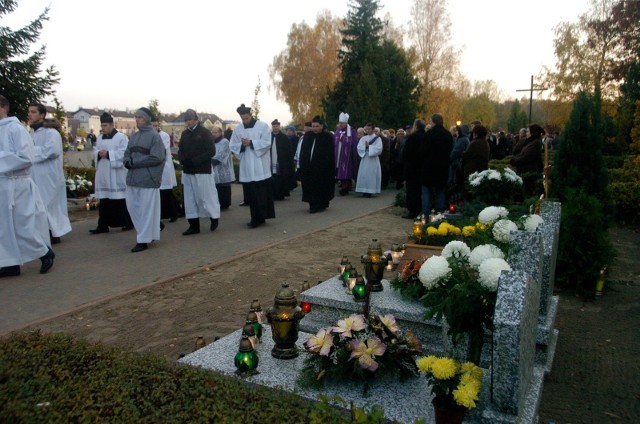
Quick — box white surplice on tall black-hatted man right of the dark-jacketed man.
[229,120,271,183]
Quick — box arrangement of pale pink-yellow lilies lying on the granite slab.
[298,314,422,391]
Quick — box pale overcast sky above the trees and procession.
[8,0,588,122]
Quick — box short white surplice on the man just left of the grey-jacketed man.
[93,132,129,199]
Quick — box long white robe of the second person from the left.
[31,127,71,237]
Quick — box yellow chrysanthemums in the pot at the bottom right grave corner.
[416,356,482,410]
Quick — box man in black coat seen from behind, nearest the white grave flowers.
[420,113,453,215]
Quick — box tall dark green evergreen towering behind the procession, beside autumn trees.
[323,0,419,128]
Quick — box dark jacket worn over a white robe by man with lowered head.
[178,123,216,174]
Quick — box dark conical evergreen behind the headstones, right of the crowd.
[550,92,610,208]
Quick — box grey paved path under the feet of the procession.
[0,185,396,335]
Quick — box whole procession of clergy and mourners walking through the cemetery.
[0,93,552,277]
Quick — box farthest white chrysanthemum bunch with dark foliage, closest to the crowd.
[468,168,524,204]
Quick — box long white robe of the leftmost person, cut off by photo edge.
[0,117,49,267]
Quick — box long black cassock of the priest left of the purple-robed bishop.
[300,131,336,210]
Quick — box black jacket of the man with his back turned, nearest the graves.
[420,125,453,188]
